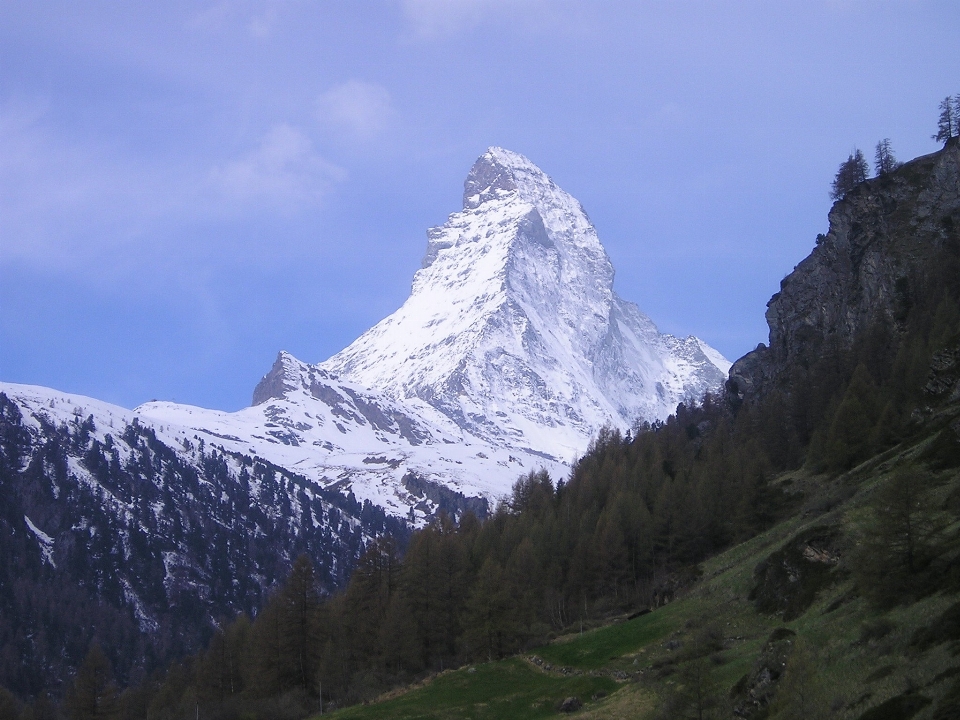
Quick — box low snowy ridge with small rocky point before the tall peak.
[136,352,548,524]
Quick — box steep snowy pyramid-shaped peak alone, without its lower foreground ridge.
[319,148,730,460]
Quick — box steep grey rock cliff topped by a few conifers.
[728,138,960,397]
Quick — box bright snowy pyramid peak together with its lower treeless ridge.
[131,148,730,522]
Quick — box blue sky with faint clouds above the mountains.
[0,0,960,410]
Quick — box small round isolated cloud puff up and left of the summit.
[317,80,394,140]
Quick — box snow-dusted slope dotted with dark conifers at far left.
[0,383,408,695]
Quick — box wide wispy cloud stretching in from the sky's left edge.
[0,98,345,272]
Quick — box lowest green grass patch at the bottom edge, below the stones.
[329,658,617,720]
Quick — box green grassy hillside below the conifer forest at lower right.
[324,424,960,720]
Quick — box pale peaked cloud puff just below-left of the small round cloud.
[211,123,344,209]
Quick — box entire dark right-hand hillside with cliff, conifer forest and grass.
[62,140,960,718]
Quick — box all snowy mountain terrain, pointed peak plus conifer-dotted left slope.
[0,148,729,692]
